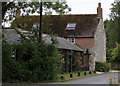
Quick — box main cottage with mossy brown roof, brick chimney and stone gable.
[11,3,106,71]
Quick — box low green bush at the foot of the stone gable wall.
[95,62,111,72]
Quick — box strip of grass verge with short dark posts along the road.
[56,71,95,82]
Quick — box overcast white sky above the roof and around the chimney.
[67,0,114,20]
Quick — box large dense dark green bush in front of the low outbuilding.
[2,41,61,82]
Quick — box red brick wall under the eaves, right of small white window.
[75,38,95,49]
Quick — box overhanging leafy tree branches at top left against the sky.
[2,0,71,21]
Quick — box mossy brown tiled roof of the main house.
[13,14,98,37]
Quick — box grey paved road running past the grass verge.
[56,72,120,84]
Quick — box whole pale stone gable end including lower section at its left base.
[90,19,106,70]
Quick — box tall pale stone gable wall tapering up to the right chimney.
[94,19,106,62]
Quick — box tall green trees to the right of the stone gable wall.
[104,0,120,63]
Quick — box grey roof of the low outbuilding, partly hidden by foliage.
[3,29,83,51]
